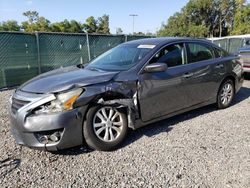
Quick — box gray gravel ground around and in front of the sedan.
[0,81,250,188]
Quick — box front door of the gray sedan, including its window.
[138,43,188,122]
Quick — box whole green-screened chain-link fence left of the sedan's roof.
[0,32,149,88]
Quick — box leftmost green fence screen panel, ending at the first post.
[0,33,38,87]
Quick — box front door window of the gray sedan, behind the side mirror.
[149,43,184,67]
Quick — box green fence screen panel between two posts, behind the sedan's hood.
[38,33,88,73]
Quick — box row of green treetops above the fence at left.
[0,11,110,34]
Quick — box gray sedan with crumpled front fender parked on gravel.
[10,38,243,151]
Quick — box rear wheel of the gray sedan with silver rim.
[217,79,235,109]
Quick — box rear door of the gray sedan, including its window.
[183,42,225,106]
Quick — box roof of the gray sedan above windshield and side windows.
[124,37,211,46]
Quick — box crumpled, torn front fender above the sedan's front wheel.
[76,81,140,129]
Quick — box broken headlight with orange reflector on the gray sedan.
[35,88,83,114]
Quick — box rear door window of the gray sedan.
[187,43,214,63]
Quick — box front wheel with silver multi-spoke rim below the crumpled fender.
[83,106,128,151]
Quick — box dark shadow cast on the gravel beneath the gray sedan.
[55,87,250,155]
